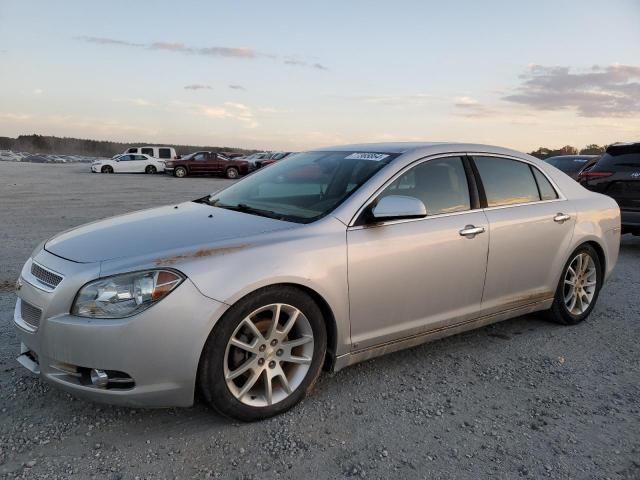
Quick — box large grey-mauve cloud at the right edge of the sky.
[502,65,640,117]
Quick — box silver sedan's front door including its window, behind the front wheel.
[347,157,489,350]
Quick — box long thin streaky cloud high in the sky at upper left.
[74,35,327,70]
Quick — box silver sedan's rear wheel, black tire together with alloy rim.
[548,245,603,325]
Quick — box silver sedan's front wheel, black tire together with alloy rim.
[198,287,327,422]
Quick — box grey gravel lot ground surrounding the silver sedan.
[0,162,640,480]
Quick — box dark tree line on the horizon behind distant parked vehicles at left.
[0,134,255,157]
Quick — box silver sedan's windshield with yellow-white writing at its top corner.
[204,151,398,223]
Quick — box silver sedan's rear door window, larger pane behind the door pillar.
[473,157,540,207]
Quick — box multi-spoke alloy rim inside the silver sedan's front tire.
[224,303,314,407]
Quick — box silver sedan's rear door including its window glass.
[473,155,575,315]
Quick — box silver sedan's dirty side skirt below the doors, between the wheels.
[333,298,553,372]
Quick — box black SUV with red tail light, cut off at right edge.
[578,142,640,235]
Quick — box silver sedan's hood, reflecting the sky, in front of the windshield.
[44,202,296,263]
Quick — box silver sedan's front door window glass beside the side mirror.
[380,157,471,215]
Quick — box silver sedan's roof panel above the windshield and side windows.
[315,142,529,157]
